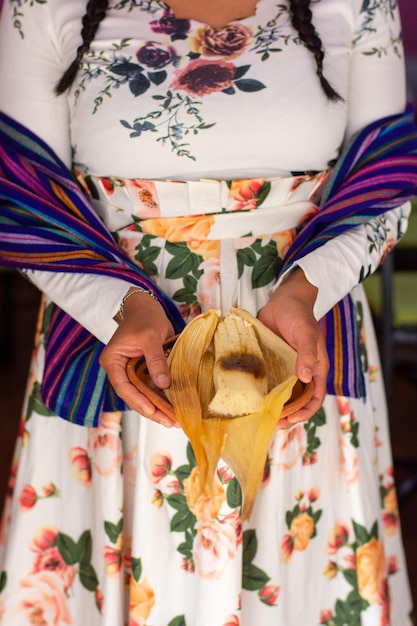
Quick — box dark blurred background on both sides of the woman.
[0,0,417,607]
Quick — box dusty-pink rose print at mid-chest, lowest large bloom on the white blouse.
[170,59,236,97]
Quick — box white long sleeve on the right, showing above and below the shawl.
[277,4,410,319]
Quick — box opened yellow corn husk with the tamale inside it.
[166,309,297,519]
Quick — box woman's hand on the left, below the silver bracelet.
[100,292,177,428]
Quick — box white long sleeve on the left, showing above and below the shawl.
[0,2,139,343]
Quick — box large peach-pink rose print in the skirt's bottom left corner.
[0,571,73,626]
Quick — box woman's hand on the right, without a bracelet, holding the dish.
[259,267,329,428]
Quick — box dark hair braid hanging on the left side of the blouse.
[55,0,109,94]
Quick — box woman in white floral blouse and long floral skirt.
[0,0,411,626]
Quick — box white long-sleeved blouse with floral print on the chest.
[0,0,408,342]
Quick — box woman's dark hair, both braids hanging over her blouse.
[55,0,341,101]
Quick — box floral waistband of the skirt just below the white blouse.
[75,172,326,238]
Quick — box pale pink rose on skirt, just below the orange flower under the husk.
[193,519,236,579]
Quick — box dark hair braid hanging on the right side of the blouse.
[290,0,342,101]
